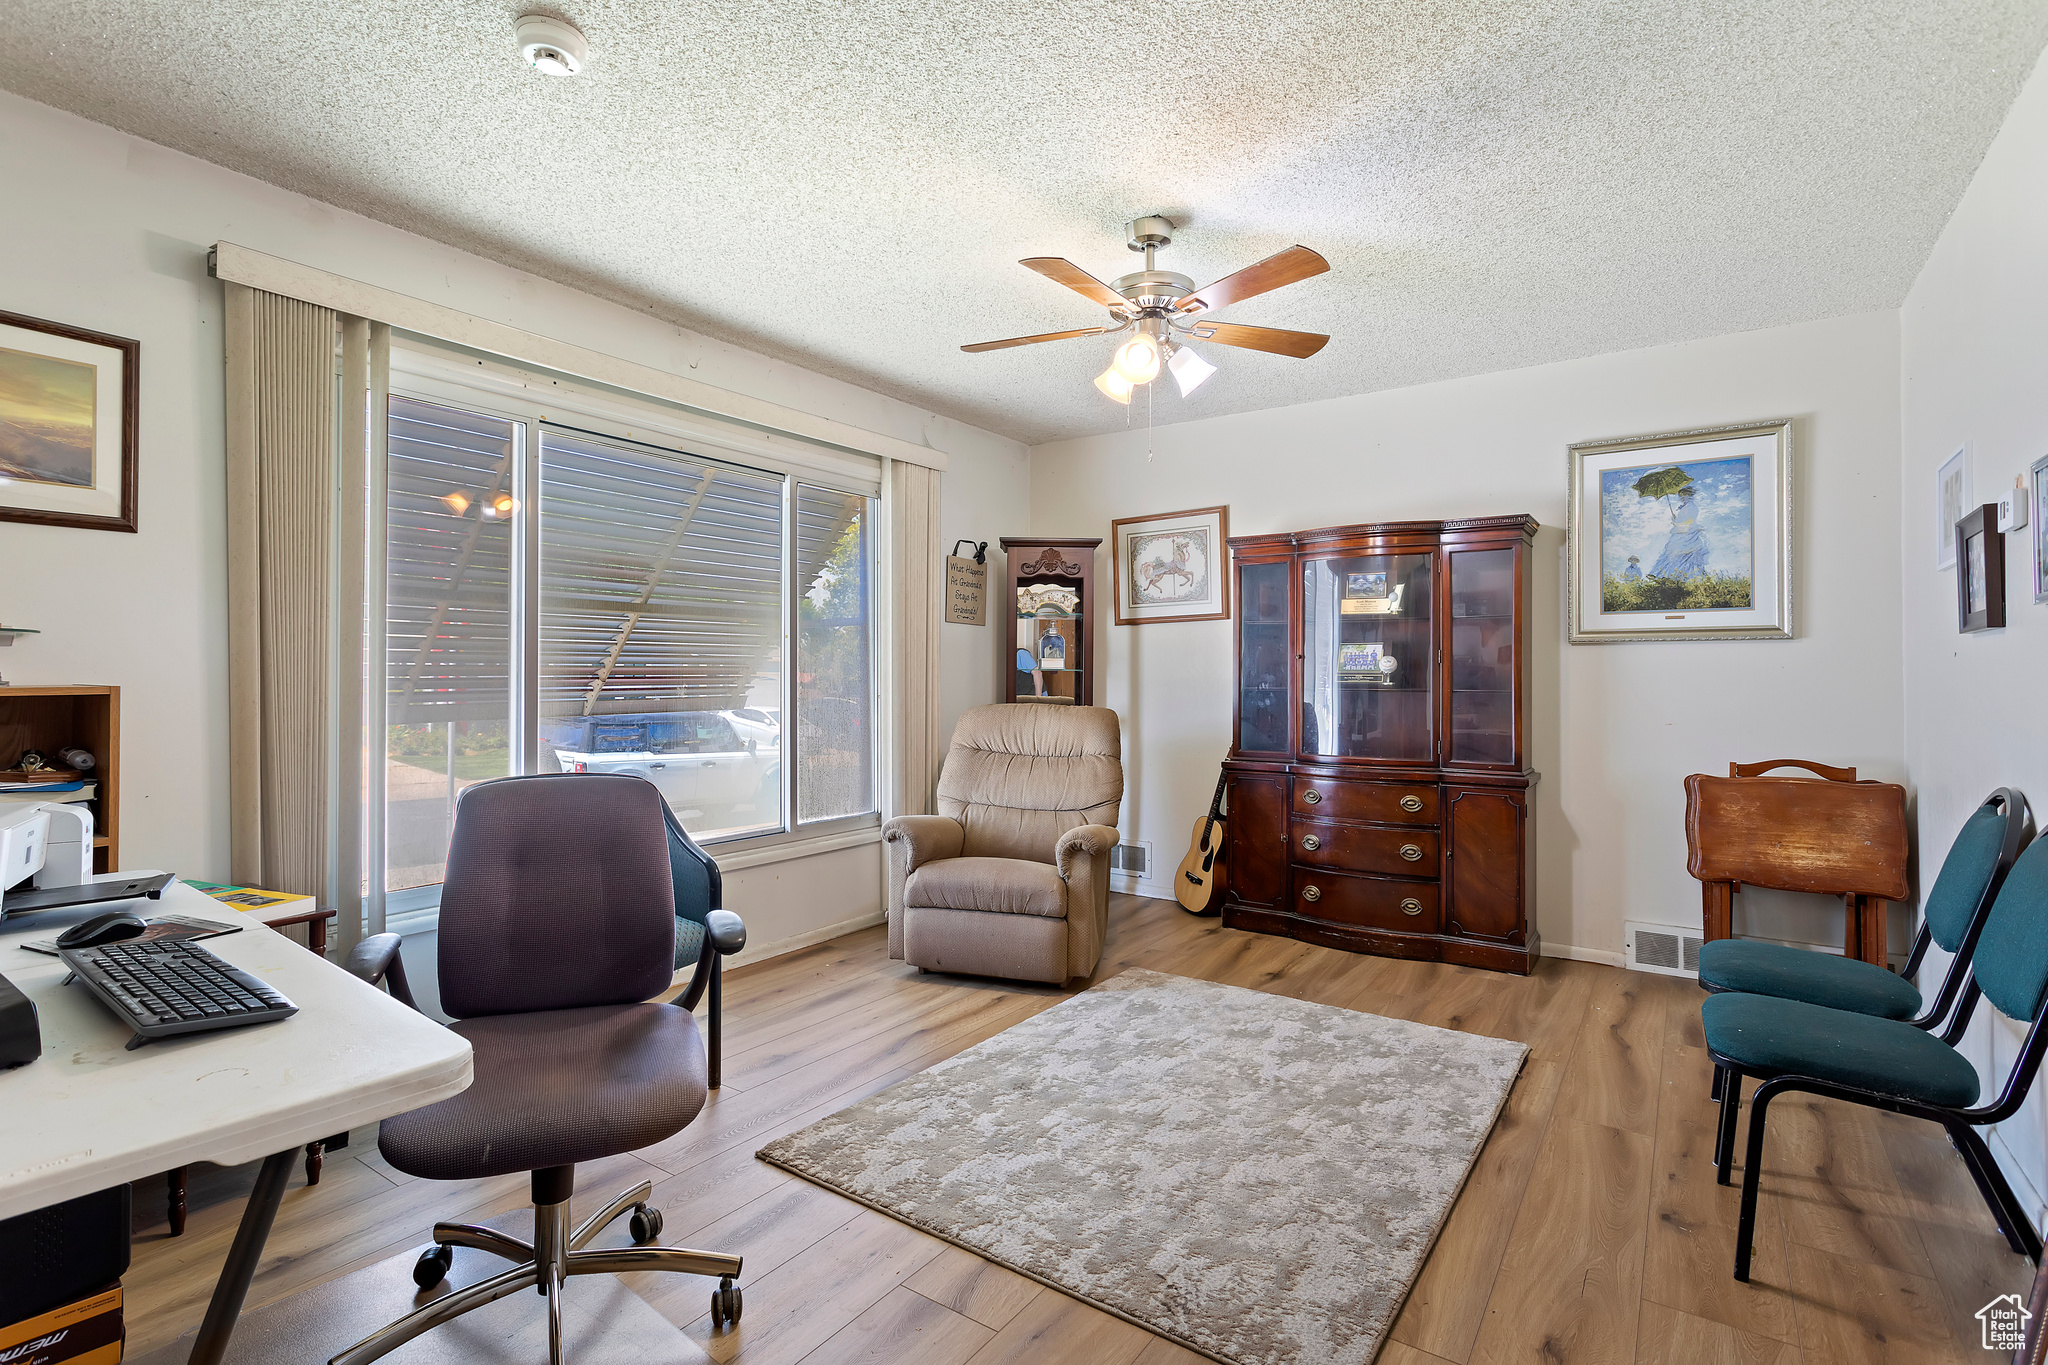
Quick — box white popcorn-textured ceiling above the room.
[0,0,2048,442]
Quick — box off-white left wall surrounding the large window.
[0,94,1026,957]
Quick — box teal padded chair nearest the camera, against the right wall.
[1700,826,2048,1279]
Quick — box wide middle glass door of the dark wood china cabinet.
[1300,555,1436,763]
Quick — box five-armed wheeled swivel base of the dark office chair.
[328,1173,741,1365]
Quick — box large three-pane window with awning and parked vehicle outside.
[383,384,877,909]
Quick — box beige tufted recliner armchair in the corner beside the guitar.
[883,704,1124,982]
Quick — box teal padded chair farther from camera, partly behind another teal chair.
[1700,786,2034,1031]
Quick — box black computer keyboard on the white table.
[57,939,299,1050]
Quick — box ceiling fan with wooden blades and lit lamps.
[961,217,1329,403]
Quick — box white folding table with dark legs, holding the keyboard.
[0,872,469,1365]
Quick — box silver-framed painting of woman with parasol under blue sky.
[1565,417,1792,645]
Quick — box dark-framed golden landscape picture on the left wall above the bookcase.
[0,313,141,530]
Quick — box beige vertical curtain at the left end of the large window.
[225,284,387,950]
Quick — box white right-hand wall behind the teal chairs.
[1901,50,2048,1214]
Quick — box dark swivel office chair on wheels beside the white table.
[330,774,743,1365]
